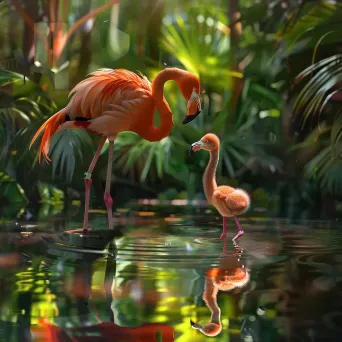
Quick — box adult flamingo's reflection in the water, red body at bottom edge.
[31,240,175,342]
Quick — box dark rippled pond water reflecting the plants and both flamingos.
[0,207,342,342]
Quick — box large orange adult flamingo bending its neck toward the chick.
[30,68,201,233]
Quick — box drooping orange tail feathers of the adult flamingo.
[29,108,67,163]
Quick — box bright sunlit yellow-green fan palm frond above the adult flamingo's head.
[161,9,243,87]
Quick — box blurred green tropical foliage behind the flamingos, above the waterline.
[0,0,342,219]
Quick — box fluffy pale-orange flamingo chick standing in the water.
[190,133,251,242]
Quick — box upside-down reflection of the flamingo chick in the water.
[190,242,250,336]
